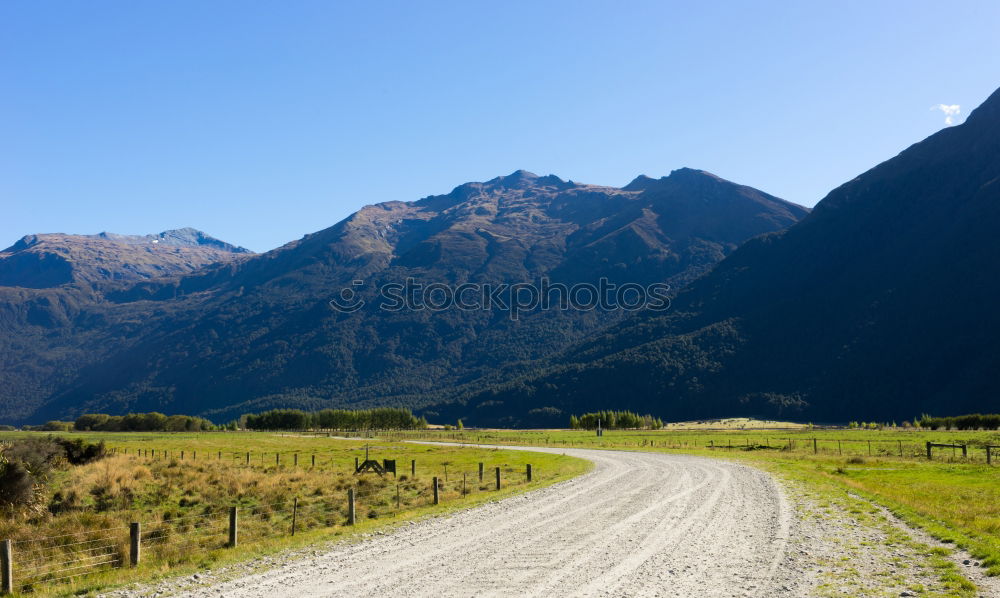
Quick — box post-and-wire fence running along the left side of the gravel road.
[0,464,539,593]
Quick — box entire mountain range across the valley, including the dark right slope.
[0,85,1000,426]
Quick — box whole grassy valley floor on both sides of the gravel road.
[0,423,1000,595]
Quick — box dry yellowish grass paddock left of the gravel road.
[0,432,590,595]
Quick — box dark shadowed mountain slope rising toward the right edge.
[450,86,1000,424]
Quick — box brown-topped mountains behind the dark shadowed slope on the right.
[0,169,808,421]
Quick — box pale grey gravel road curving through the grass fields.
[176,447,794,598]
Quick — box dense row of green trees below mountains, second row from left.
[242,407,427,430]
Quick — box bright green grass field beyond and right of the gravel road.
[382,428,1000,575]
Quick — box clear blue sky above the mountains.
[0,0,1000,251]
